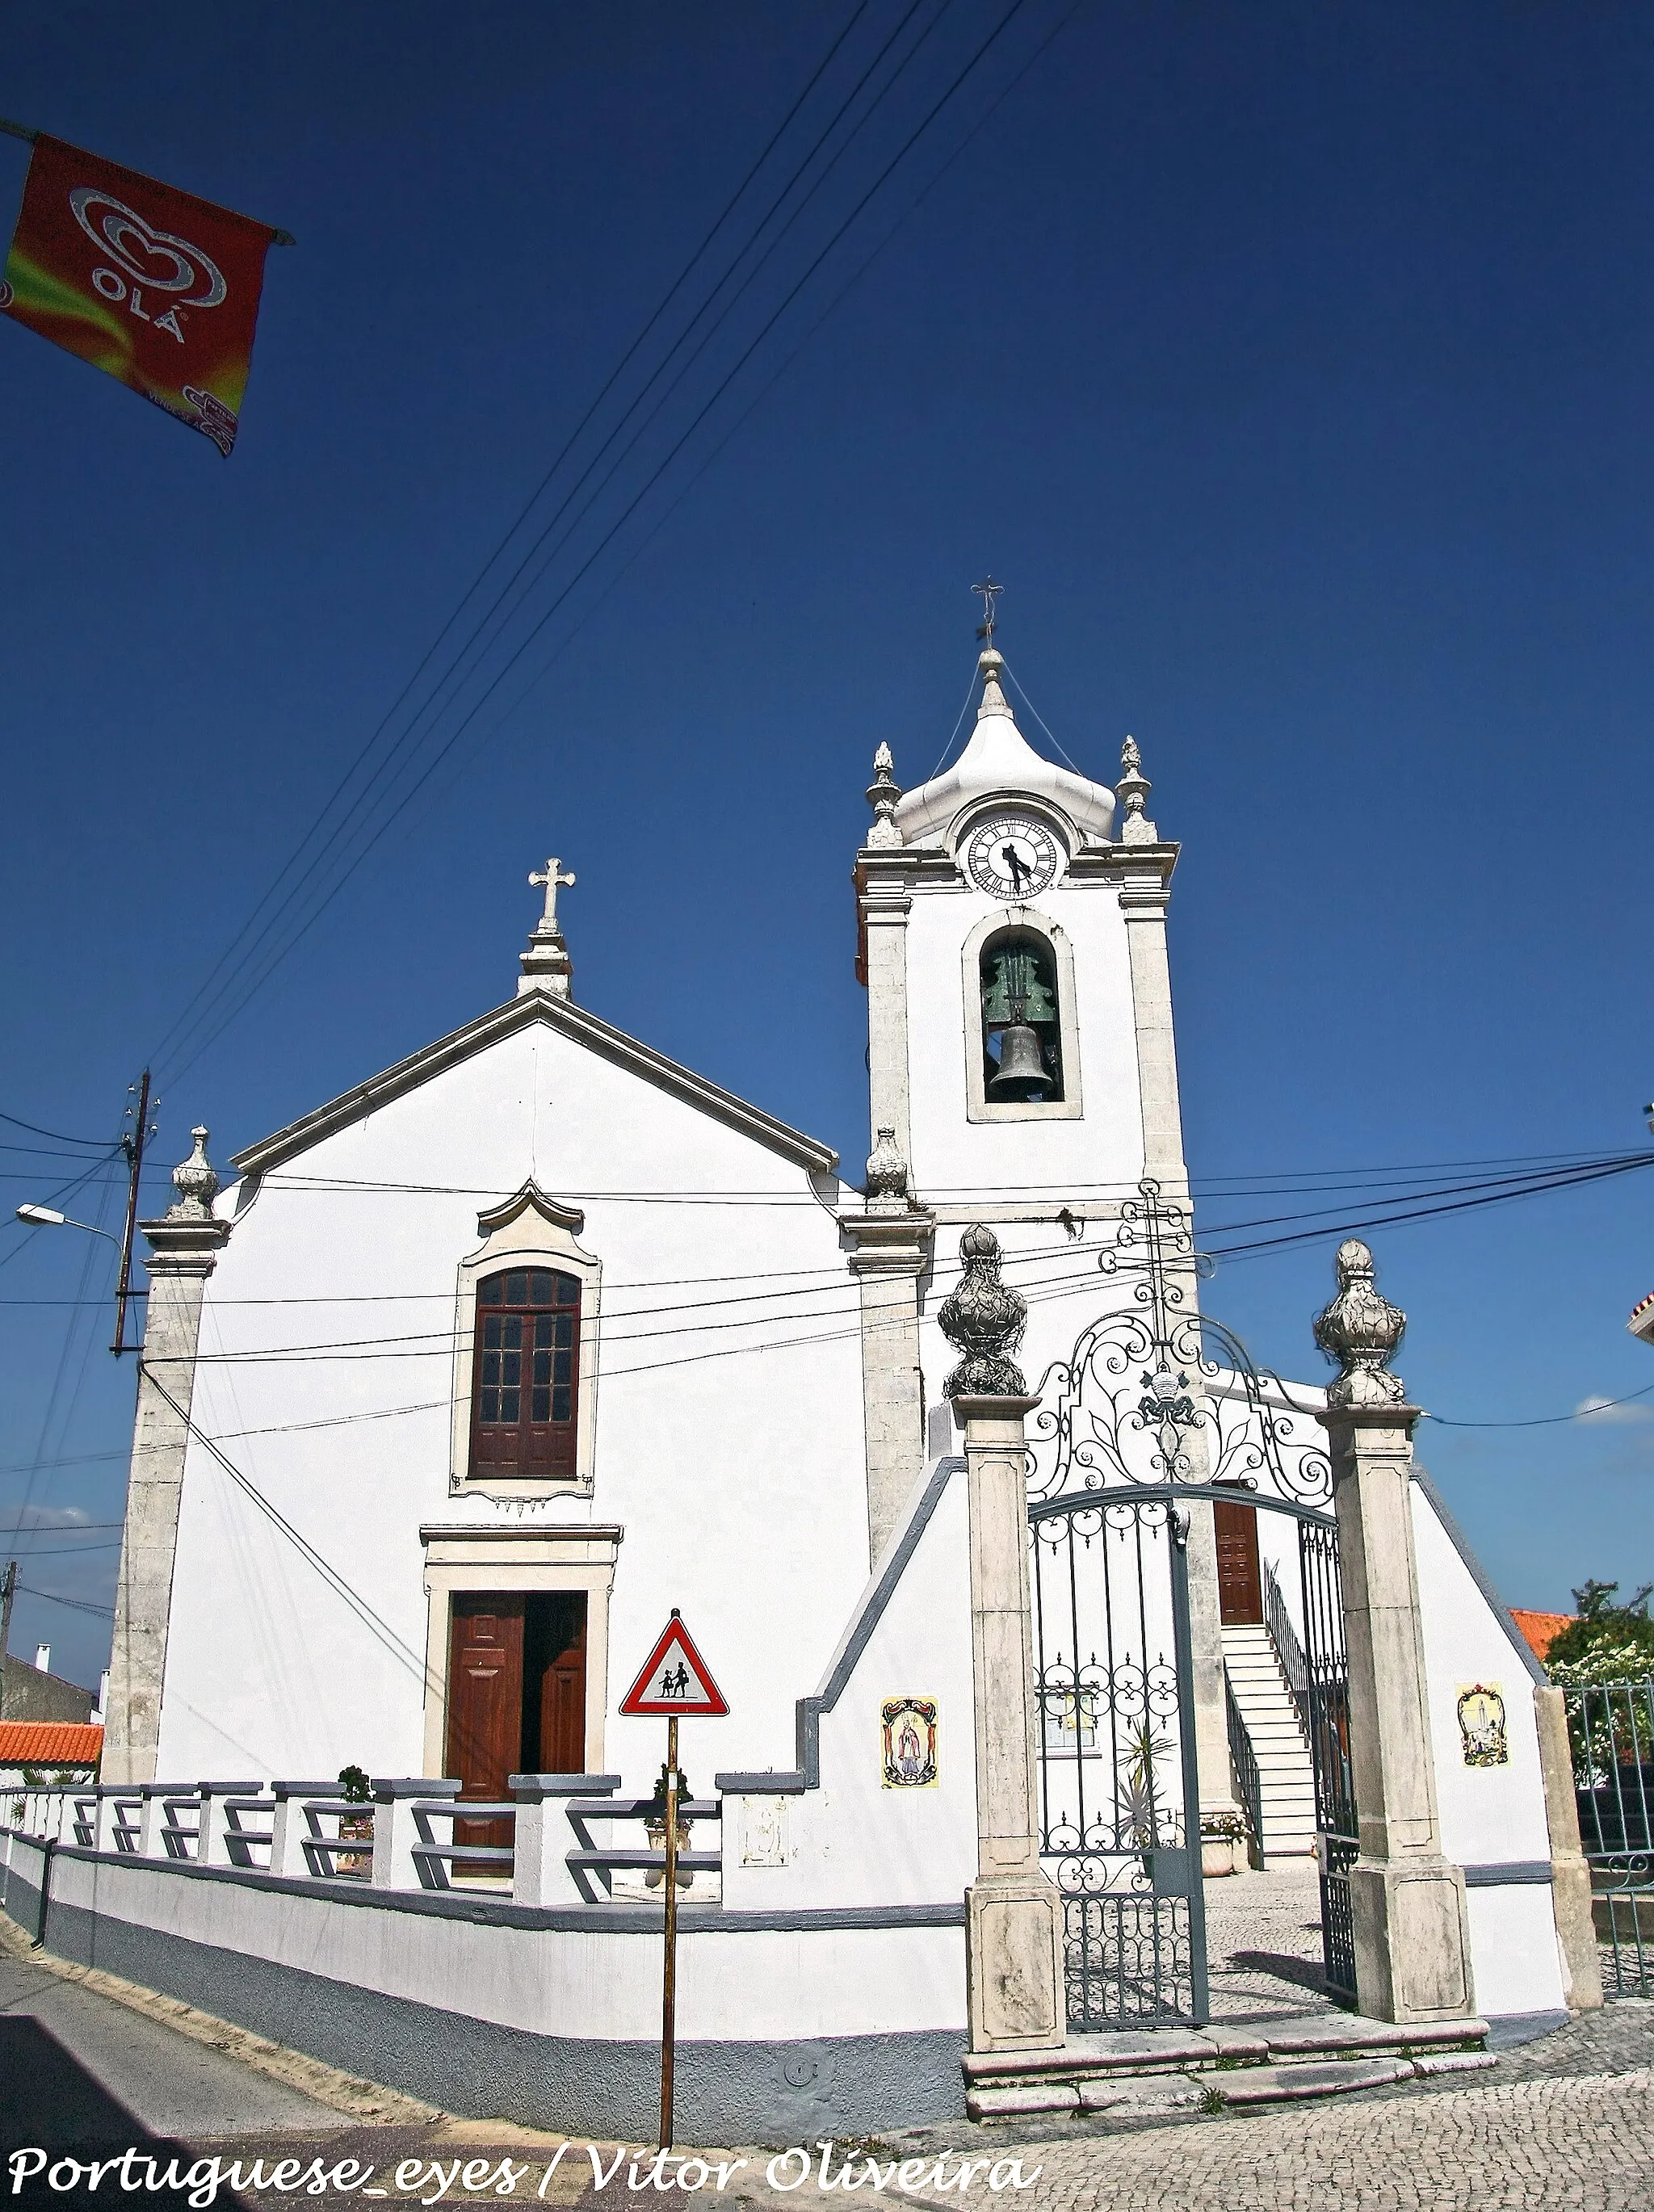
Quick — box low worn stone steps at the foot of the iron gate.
[964,2013,1497,2119]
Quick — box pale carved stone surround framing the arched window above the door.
[449,1183,603,1500]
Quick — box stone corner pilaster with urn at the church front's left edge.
[99,1128,230,1783]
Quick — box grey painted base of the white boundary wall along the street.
[6,1865,964,2146]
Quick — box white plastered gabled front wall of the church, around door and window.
[159,1024,867,1790]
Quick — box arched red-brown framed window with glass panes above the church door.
[471,1267,579,1478]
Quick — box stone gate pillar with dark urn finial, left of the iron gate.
[938,1225,1066,2050]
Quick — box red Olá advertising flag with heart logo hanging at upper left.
[0,132,276,455]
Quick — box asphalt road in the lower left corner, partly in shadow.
[0,1954,341,2150]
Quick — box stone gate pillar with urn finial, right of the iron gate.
[1316,1236,1475,2021]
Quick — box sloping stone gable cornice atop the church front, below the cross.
[234,991,838,1174]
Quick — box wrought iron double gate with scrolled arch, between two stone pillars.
[1028,1183,1355,2030]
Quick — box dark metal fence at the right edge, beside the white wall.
[1564,1681,1654,1997]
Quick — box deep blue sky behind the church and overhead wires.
[0,0,1654,1681]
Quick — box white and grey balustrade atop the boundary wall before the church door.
[0,1774,723,1904]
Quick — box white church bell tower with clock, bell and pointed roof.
[842,619,1187,1557]
